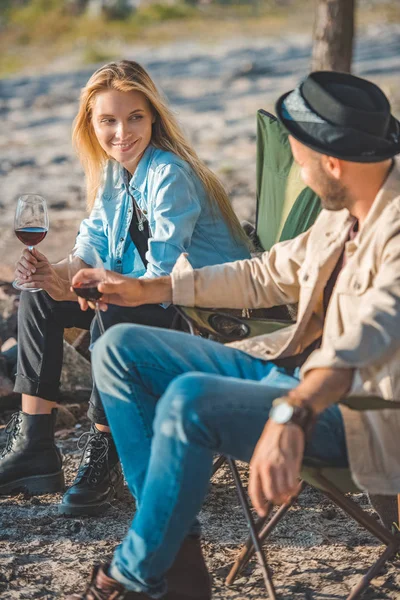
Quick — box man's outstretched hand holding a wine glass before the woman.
[72,269,144,311]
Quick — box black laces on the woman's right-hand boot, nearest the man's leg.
[75,431,110,485]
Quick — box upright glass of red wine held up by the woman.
[13,194,49,292]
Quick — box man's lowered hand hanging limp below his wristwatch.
[249,420,305,517]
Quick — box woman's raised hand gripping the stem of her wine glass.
[15,248,72,300]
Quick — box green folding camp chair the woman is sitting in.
[175,110,321,343]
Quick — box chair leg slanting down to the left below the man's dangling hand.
[225,480,307,585]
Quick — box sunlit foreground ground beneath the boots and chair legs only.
[0,408,400,600]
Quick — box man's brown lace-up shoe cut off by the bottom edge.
[65,565,151,600]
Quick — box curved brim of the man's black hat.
[275,90,400,163]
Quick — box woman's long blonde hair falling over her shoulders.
[72,60,246,240]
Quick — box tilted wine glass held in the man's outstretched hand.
[68,246,106,334]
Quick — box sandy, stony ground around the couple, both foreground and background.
[0,25,400,600]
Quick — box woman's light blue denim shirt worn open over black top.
[76,145,250,277]
